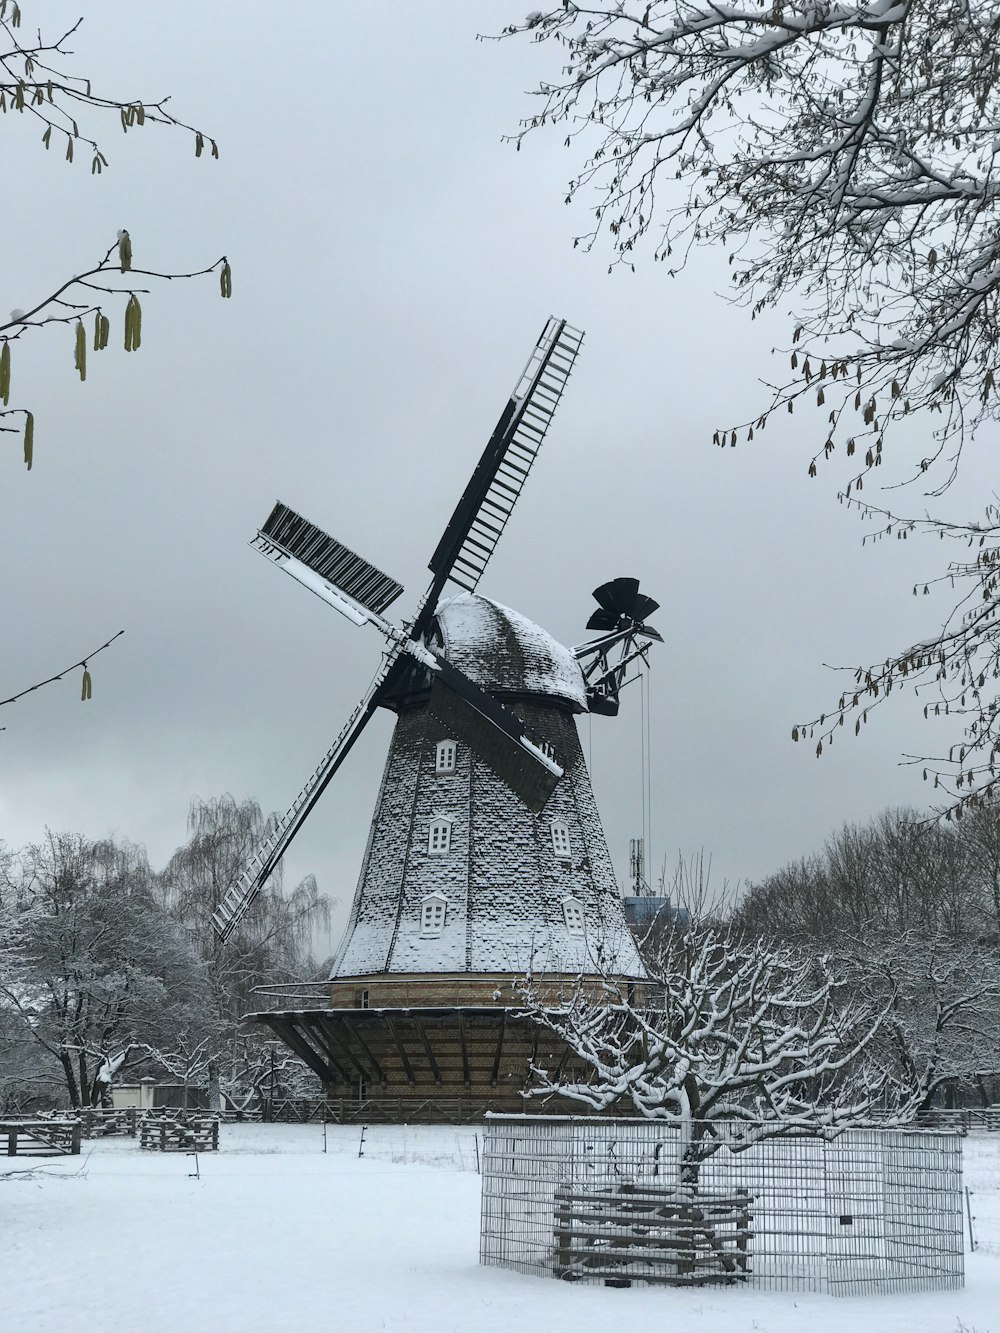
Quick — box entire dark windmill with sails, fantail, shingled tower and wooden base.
[215,320,660,1120]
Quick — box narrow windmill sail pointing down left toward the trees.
[212,647,401,941]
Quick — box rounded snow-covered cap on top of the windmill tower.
[437,593,587,712]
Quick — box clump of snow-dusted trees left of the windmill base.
[0,796,329,1108]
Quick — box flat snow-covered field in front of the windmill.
[0,1125,1000,1333]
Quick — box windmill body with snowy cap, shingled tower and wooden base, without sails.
[256,593,645,1120]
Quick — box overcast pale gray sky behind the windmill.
[0,0,976,954]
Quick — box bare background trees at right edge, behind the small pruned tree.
[733,809,1000,1110]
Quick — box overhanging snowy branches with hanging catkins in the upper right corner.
[505,0,1000,809]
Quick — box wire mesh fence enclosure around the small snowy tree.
[480,1116,964,1296]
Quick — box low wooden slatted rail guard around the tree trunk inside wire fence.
[553,1184,753,1286]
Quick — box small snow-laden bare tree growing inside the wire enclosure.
[528,924,885,1182]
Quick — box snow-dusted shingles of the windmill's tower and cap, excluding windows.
[332,595,643,986]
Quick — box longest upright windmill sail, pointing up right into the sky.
[415,319,583,632]
